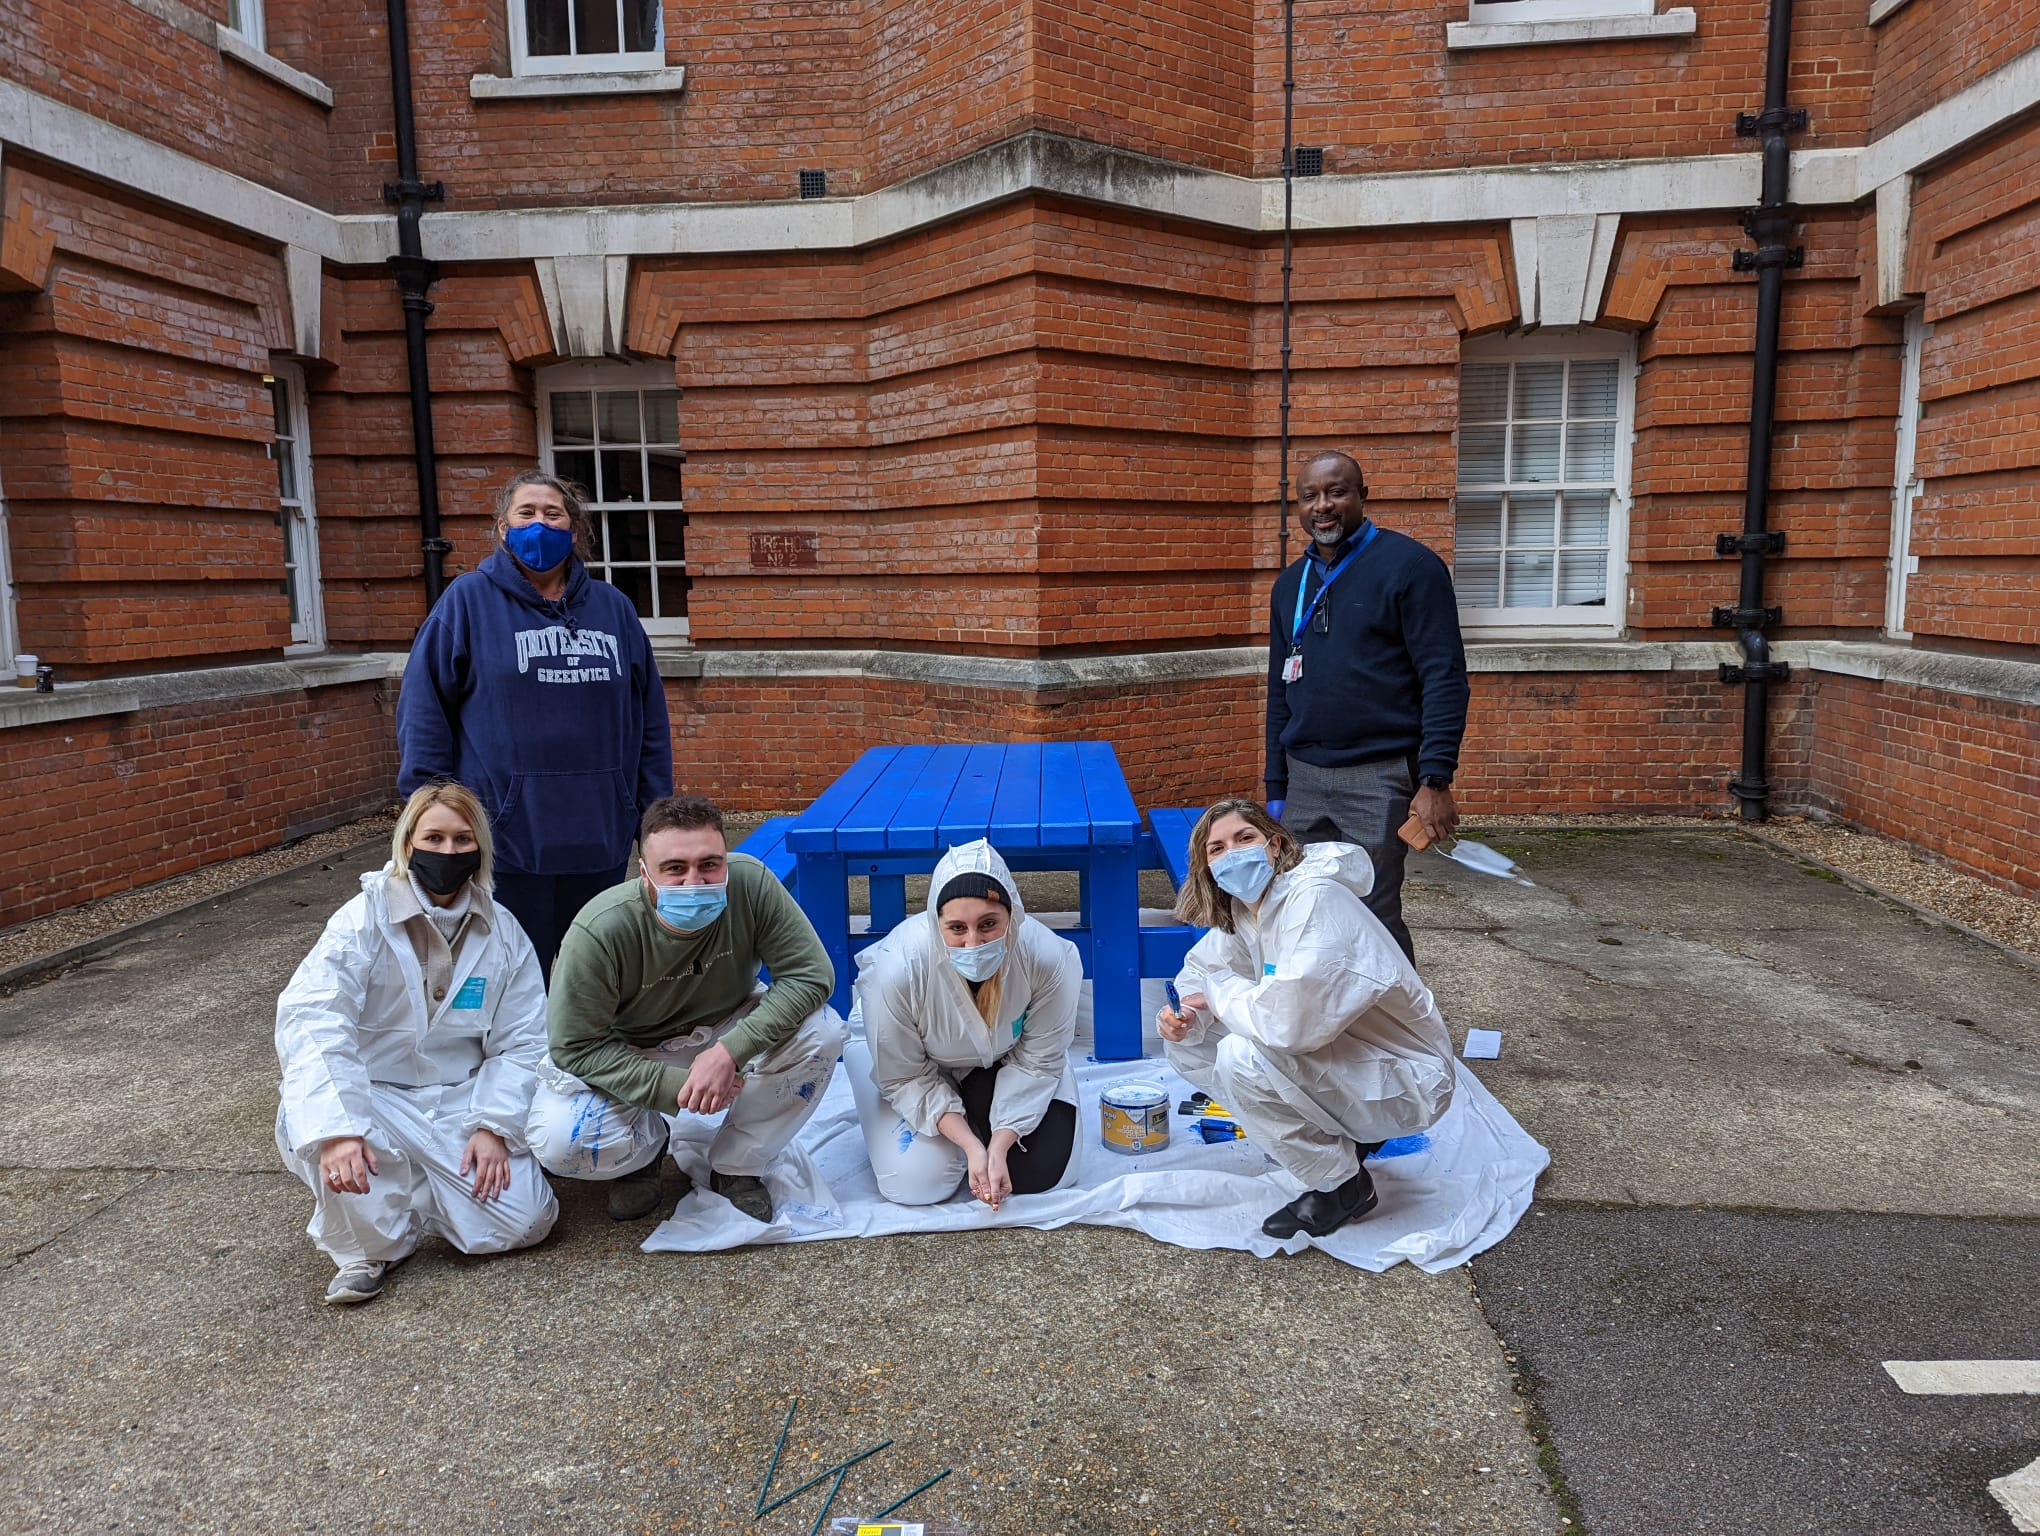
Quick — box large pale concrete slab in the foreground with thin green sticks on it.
[0,1173,1557,1536]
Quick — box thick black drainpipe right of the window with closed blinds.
[1714,0,1807,822]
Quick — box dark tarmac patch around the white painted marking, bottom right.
[1473,1206,2040,1536]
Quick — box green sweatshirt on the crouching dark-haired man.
[547,853,836,1114]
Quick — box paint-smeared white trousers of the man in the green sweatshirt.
[528,1004,849,1179]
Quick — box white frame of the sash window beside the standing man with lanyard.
[1450,326,1638,641]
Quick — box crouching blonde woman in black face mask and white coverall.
[275,783,559,1303]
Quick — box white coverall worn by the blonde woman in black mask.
[275,865,559,1267]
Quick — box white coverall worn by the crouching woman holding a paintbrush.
[1167,842,1452,1189]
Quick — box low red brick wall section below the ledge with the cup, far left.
[0,683,396,928]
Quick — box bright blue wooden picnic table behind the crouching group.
[743,740,1200,1061]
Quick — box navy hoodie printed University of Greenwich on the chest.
[396,549,673,875]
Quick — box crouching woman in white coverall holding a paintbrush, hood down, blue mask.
[1155,800,1452,1238]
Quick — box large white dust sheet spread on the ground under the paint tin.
[645,1052,1550,1273]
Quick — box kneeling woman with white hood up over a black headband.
[845,838,1083,1210]
